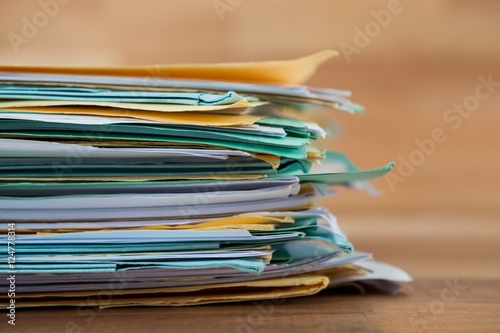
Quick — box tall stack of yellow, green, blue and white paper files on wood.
[0,50,411,308]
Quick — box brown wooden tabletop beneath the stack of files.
[1,212,500,333]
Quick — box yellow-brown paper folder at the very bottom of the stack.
[9,274,329,309]
